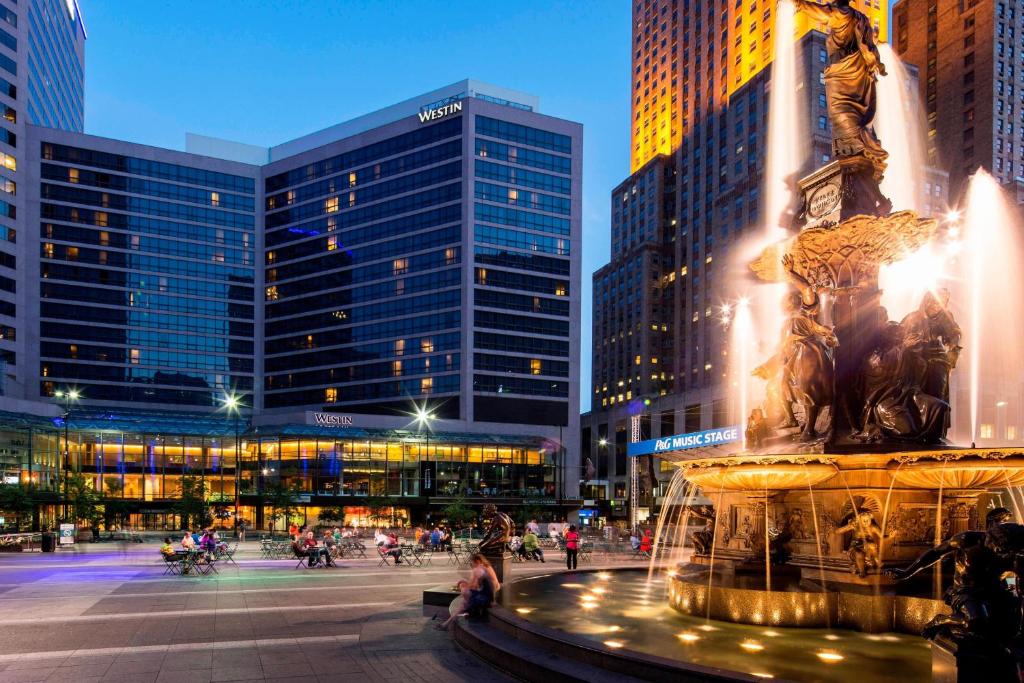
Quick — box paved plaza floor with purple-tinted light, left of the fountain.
[0,542,647,683]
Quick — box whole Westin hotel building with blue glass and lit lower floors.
[0,78,582,528]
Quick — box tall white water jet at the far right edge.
[959,170,1024,443]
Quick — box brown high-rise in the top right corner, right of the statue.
[893,0,1024,202]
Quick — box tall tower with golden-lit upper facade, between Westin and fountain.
[581,0,889,518]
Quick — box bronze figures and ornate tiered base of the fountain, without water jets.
[664,0,1024,679]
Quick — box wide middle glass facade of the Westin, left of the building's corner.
[263,117,463,419]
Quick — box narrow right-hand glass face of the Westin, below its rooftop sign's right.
[473,115,580,425]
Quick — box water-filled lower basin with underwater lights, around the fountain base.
[492,569,932,683]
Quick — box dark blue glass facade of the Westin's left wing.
[33,137,256,408]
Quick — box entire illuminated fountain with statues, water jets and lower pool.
[468,0,1024,680]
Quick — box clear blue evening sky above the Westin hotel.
[81,0,631,411]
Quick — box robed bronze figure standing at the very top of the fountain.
[793,0,892,218]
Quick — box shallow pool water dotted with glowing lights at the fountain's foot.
[503,570,932,683]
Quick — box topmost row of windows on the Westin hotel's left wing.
[41,142,256,195]
